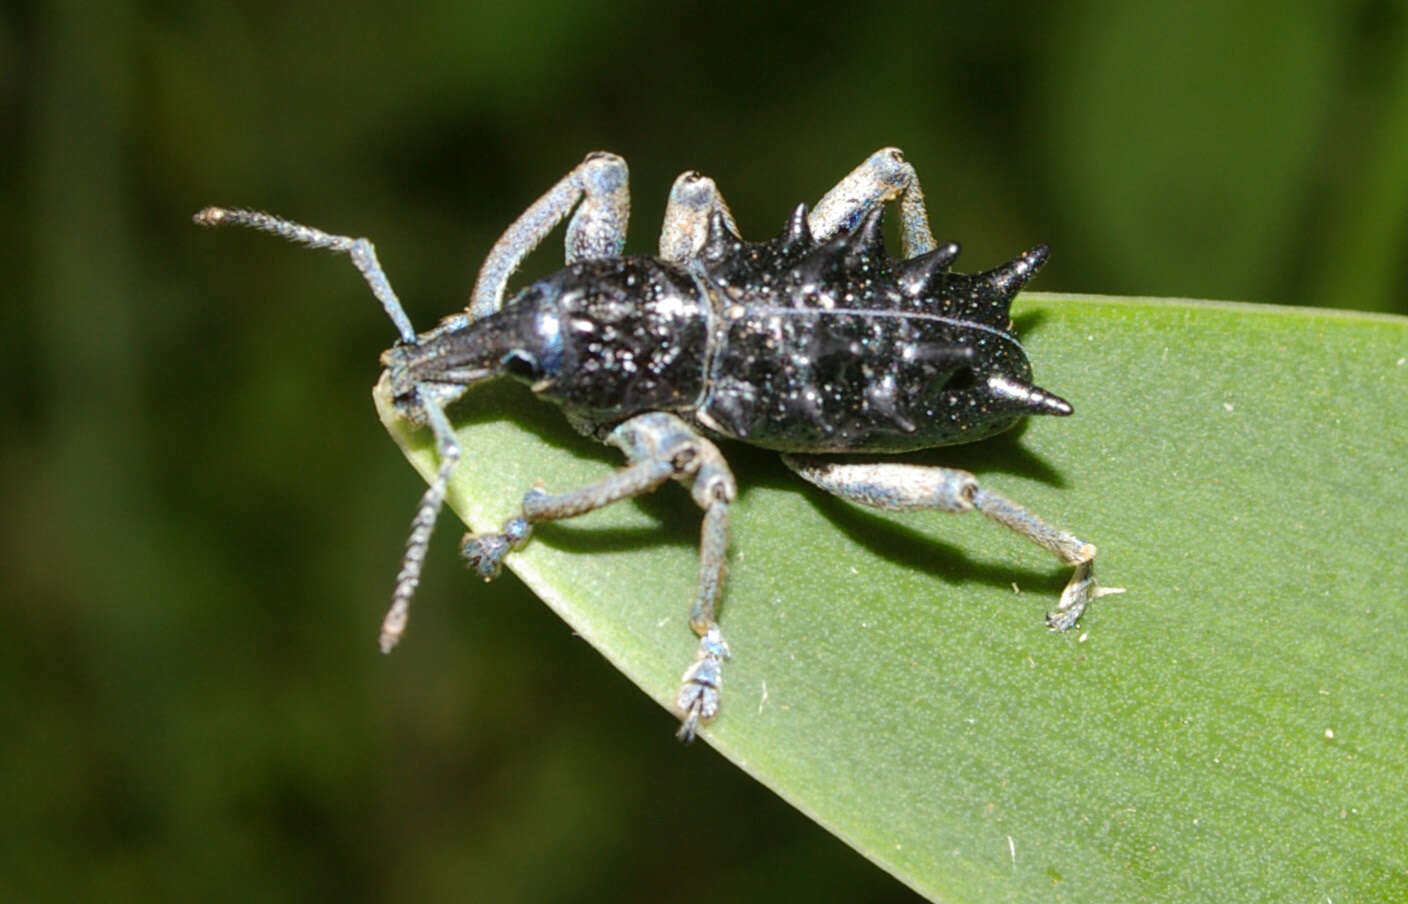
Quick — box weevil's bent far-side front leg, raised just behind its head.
[469,151,631,320]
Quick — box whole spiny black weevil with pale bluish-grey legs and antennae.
[196,148,1115,739]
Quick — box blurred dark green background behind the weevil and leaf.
[0,0,1408,901]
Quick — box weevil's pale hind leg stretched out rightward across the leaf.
[783,455,1124,631]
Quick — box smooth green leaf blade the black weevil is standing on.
[379,294,1408,901]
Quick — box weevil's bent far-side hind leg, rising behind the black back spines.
[807,148,956,258]
